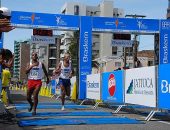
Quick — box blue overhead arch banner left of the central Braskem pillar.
[11,11,79,30]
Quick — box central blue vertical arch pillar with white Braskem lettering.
[78,16,92,99]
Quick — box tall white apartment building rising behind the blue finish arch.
[61,0,124,58]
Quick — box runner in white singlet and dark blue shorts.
[54,53,72,111]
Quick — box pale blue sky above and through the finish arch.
[0,0,168,51]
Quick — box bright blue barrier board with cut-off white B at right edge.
[158,64,170,110]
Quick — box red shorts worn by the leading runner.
[27,79,42,89]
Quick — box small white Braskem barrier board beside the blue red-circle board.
[86,74,101,100]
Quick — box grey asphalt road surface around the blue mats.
[0,91,170,130]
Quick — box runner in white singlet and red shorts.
[26,52,49,115]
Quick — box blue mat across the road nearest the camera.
[18,118,143,126]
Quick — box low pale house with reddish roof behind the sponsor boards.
[92,50,155,73]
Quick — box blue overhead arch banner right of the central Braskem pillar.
[93,17,159,33]
